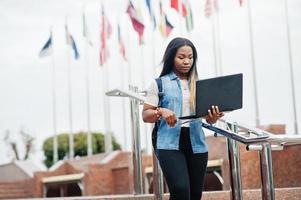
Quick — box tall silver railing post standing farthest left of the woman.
[129,86,143,194]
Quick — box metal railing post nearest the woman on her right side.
[227,123,243,200]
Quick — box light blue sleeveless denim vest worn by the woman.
[157,72,208,153]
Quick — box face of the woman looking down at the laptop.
[174,45,193,79]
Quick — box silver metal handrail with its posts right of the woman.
[203,119,301,200]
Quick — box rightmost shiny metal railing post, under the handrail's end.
[260,143,275,200]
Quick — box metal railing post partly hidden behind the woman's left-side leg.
[153,150,164,200]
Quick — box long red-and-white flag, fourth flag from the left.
[99,5,112,66]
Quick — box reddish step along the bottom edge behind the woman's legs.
[11,187,301,200]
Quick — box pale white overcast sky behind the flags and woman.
[0,0,301,164]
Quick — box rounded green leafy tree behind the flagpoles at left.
[43,132,121,167]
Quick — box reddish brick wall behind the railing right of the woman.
[206,124,301,190]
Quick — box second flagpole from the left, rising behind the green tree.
[66,17,74,159]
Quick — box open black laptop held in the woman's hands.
[179,73,243,119]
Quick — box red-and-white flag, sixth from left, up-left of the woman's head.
[126,1,144,44]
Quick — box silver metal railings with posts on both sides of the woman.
[106,86,301,200]
